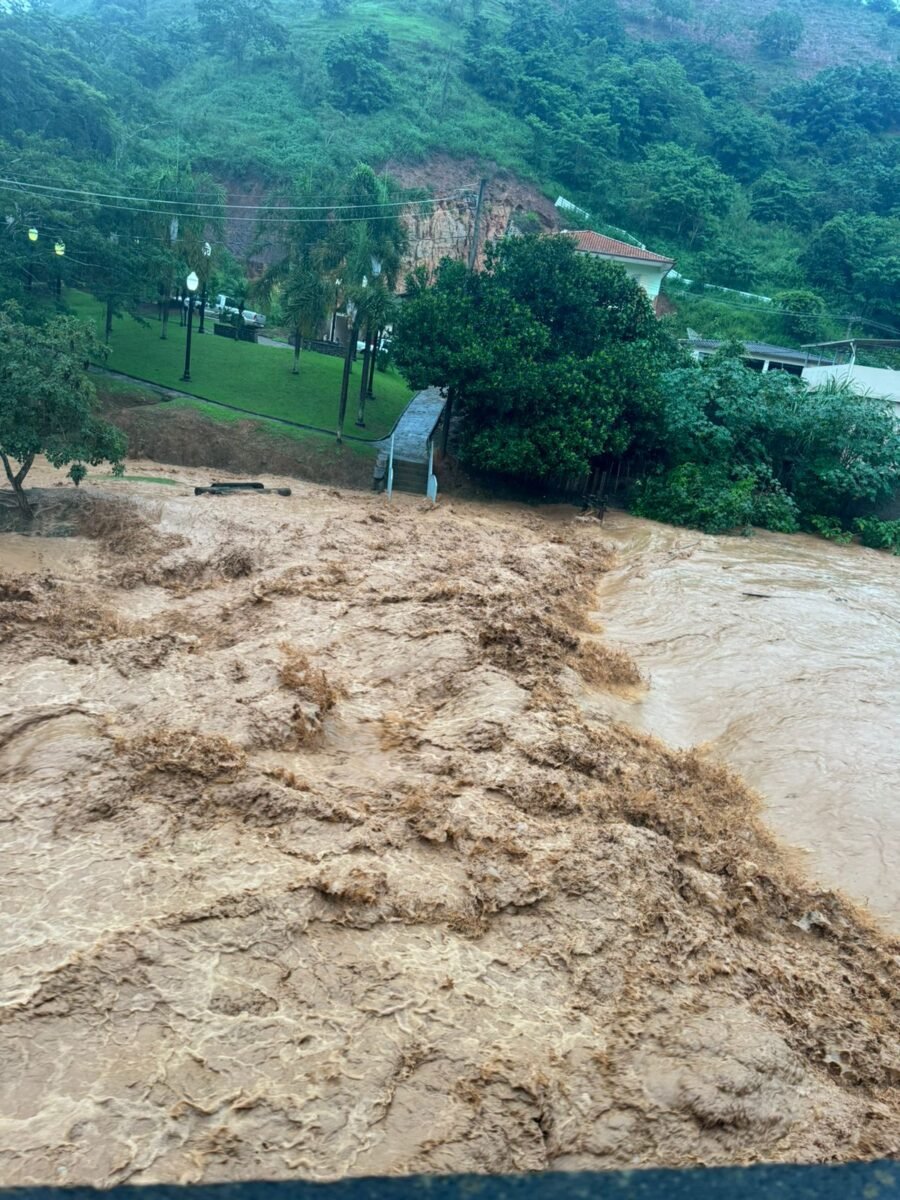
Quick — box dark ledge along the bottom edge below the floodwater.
[0,1160,900,1200]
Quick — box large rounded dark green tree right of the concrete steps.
[395,236,672,480]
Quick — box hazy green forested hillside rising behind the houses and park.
[0,0,900,341]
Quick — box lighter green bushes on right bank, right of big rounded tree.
[632,344,900,533]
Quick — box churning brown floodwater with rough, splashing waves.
[0,468,900,1184]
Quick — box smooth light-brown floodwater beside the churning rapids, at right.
[598,514,900,930]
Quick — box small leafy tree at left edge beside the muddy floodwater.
[0,305,125,516]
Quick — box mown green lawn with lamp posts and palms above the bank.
[74,292,412,440]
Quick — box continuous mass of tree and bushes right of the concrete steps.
[395,238,900,548]
